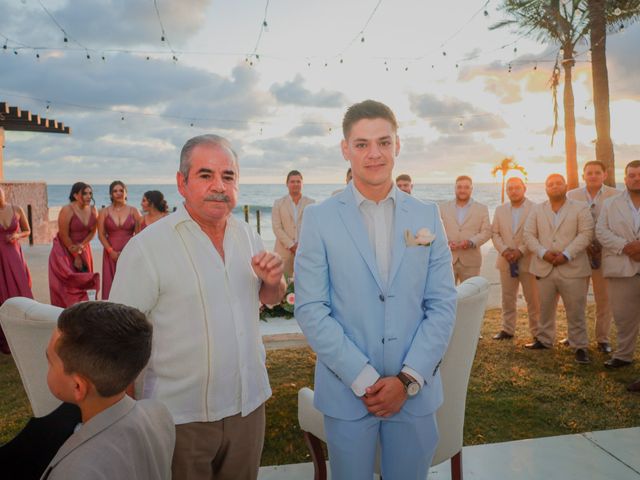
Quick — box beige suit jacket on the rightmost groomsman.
[596,192,640,277]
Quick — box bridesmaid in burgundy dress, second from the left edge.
[49,182,100,308]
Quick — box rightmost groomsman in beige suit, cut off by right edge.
[596,160,640,391]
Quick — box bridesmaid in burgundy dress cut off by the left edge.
[0,187,33,353]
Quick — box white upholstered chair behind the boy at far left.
[0,297,62,417]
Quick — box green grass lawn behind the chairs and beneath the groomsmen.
[0,306,640,465]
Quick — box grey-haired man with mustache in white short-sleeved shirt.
[110,135,285,480]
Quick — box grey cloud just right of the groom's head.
[409,93,507,135]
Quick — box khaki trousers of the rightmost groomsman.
[609,275,640,362]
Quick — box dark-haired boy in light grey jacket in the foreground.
[42,302,175,480]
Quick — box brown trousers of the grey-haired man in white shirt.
[171,404,265,480]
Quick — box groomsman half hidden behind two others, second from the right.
[567,160,620,353]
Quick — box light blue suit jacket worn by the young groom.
[295,184,456,420]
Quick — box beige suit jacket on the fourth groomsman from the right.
[491,198,534,272]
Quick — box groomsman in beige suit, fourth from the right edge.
[491,177,540,340]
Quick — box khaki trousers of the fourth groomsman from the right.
[500,269,540,337]
